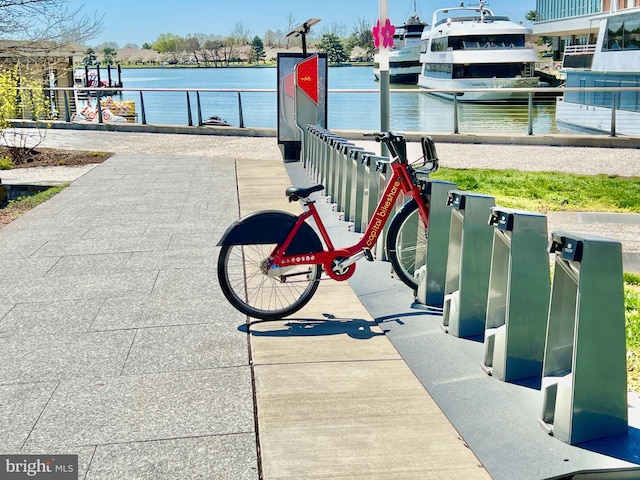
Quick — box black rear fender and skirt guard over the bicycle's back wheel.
[218,210,323,255]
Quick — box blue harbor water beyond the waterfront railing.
[117,67,557,134]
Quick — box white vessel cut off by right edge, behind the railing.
[556,8,640,135]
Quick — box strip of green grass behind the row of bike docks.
[433,168,640,213]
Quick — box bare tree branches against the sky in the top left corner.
[0,0,103,50]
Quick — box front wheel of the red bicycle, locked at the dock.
[386,199,428,290]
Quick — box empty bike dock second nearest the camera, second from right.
[482,207,551,387]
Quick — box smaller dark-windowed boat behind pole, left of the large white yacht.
[373,1,427,85]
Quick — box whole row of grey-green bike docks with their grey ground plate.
[296,125,640,480]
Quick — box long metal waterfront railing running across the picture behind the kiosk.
[12,86,640,136]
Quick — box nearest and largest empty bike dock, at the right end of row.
[540,232,629,445]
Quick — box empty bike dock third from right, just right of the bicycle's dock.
[442,190,495,337]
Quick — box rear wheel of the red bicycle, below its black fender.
[218,244,322,320]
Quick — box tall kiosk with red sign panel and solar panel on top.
[278,18,328,162]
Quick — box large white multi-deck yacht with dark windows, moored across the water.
[418,1,539,102]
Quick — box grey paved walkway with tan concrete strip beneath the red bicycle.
[0,131,640,479]
